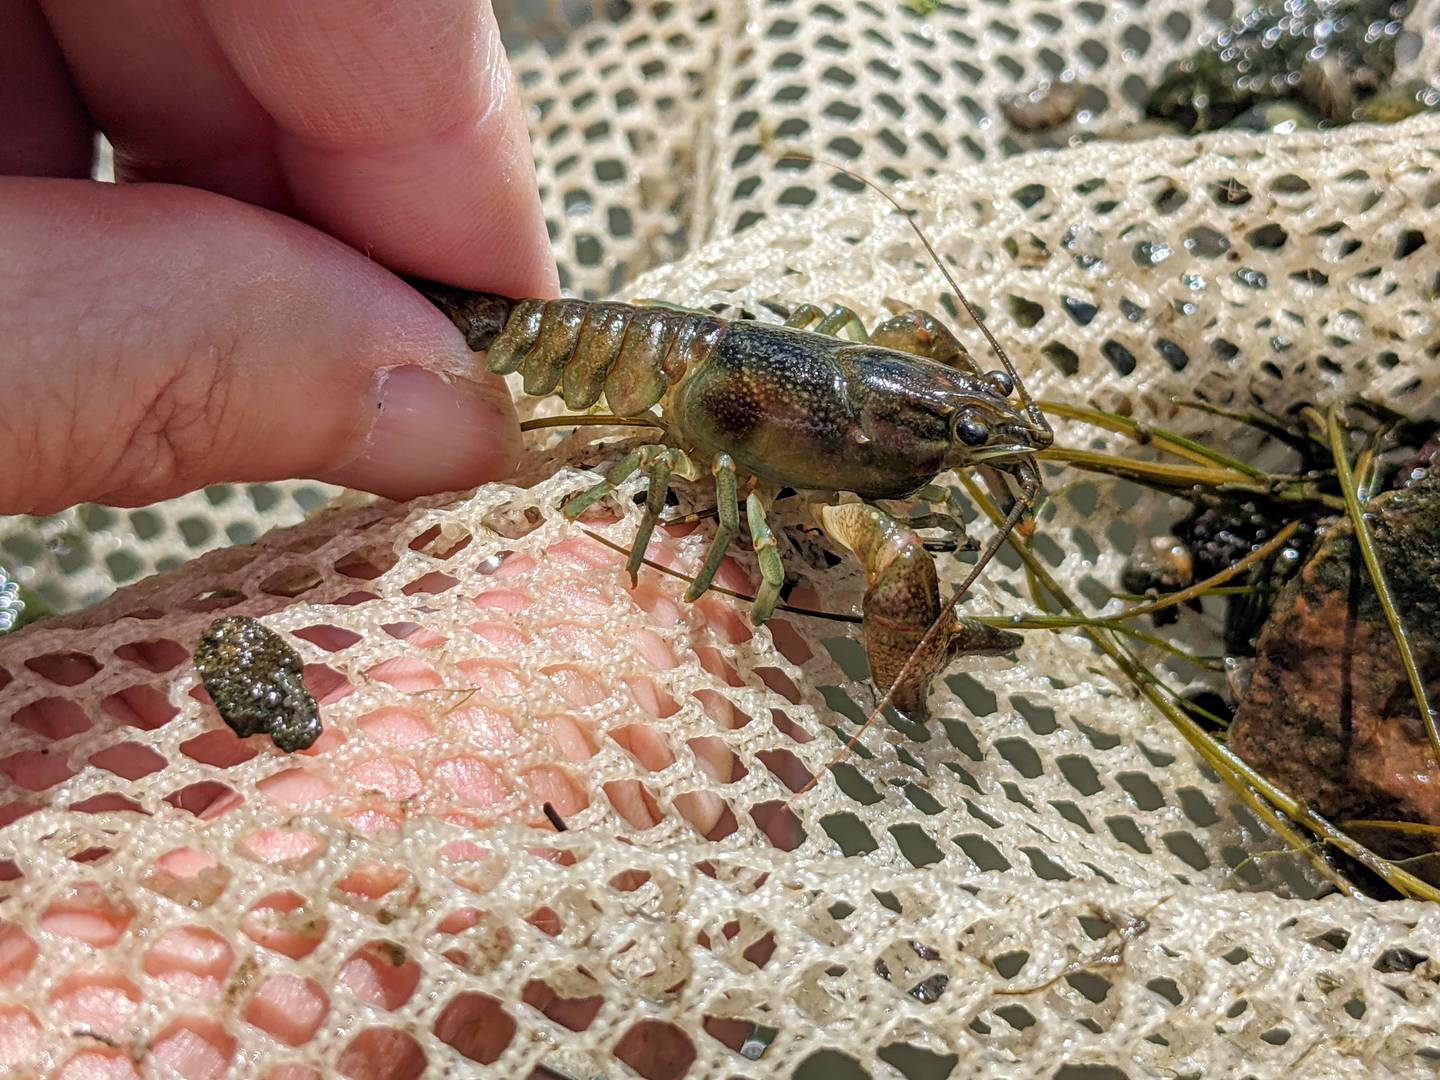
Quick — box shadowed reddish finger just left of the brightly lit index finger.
[45,0,289,210]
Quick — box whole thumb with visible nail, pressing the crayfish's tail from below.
[0,177,518,514]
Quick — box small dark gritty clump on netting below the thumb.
[194,615,321,753]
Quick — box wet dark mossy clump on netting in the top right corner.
[1145,0,1434,132]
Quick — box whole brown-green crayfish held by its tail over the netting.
[415,264,1053,717]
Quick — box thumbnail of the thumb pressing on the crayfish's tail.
[318,367,520,498]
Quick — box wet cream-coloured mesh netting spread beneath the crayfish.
[0,0,1440,1080]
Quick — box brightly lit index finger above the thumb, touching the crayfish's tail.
[200,0,556,295]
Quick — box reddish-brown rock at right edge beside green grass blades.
[1230,472,1440,881]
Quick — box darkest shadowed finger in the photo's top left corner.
[0,0,94,176]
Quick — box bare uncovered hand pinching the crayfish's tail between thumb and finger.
[0,0,556,513]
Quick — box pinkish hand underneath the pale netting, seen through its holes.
[0,512,789,1080]
